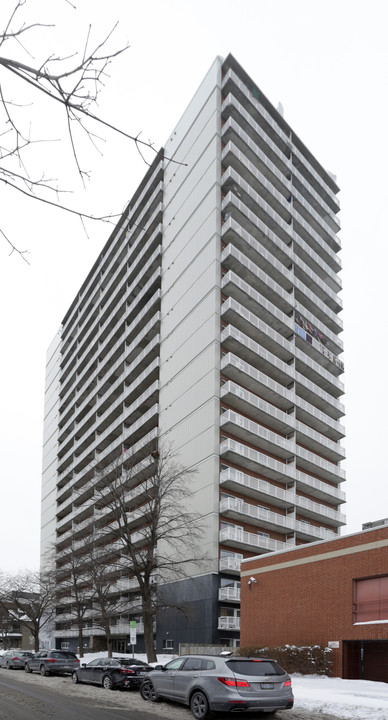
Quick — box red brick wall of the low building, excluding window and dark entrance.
[240,526,388,675]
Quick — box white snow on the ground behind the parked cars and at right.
[75,653,388,720]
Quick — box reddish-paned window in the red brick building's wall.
[353,575,388,623]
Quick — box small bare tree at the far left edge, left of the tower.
[0,570,56,651]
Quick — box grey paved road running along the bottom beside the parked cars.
[0,669,346,720]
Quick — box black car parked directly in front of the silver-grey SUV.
[72,658,152,690]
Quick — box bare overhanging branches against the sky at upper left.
[0,0,185,262]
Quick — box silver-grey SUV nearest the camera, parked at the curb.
[140,655,294,720]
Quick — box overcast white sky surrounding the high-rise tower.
[0,0,388,570]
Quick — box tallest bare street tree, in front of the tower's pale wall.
[95,447,205,662]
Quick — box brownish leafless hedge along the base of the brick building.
[238,645,333,675]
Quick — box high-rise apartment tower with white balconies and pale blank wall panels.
[42,55,345,652]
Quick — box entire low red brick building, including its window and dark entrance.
[240,525,388,682]
